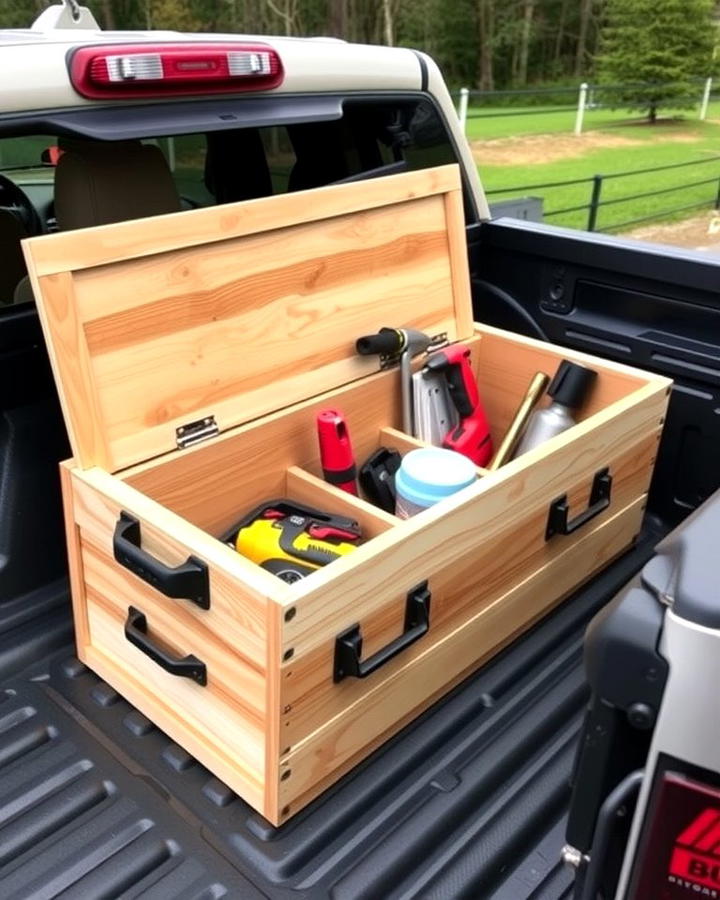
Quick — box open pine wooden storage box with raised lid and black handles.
[25,167,670,824]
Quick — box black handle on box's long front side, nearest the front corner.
[333,581,431,683]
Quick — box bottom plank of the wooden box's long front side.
[279,497,645,821]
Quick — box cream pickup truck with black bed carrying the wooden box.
[0,3,720,900]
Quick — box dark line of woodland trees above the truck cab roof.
[0,0,718,90]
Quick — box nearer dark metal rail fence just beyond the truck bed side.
[486,156,720,231]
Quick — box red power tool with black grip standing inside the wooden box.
[425,344,493,466]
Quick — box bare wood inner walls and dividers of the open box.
[121,326,643,588]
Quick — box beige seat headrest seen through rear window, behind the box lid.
[55,138,181,231]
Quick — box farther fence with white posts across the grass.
[457,78,713,134]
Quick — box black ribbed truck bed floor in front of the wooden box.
[0,524,662,900]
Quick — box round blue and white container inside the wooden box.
[395,447,477,519]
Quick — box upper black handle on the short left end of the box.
[113,512,210,609]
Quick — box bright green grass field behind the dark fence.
[468,102,720,230]
